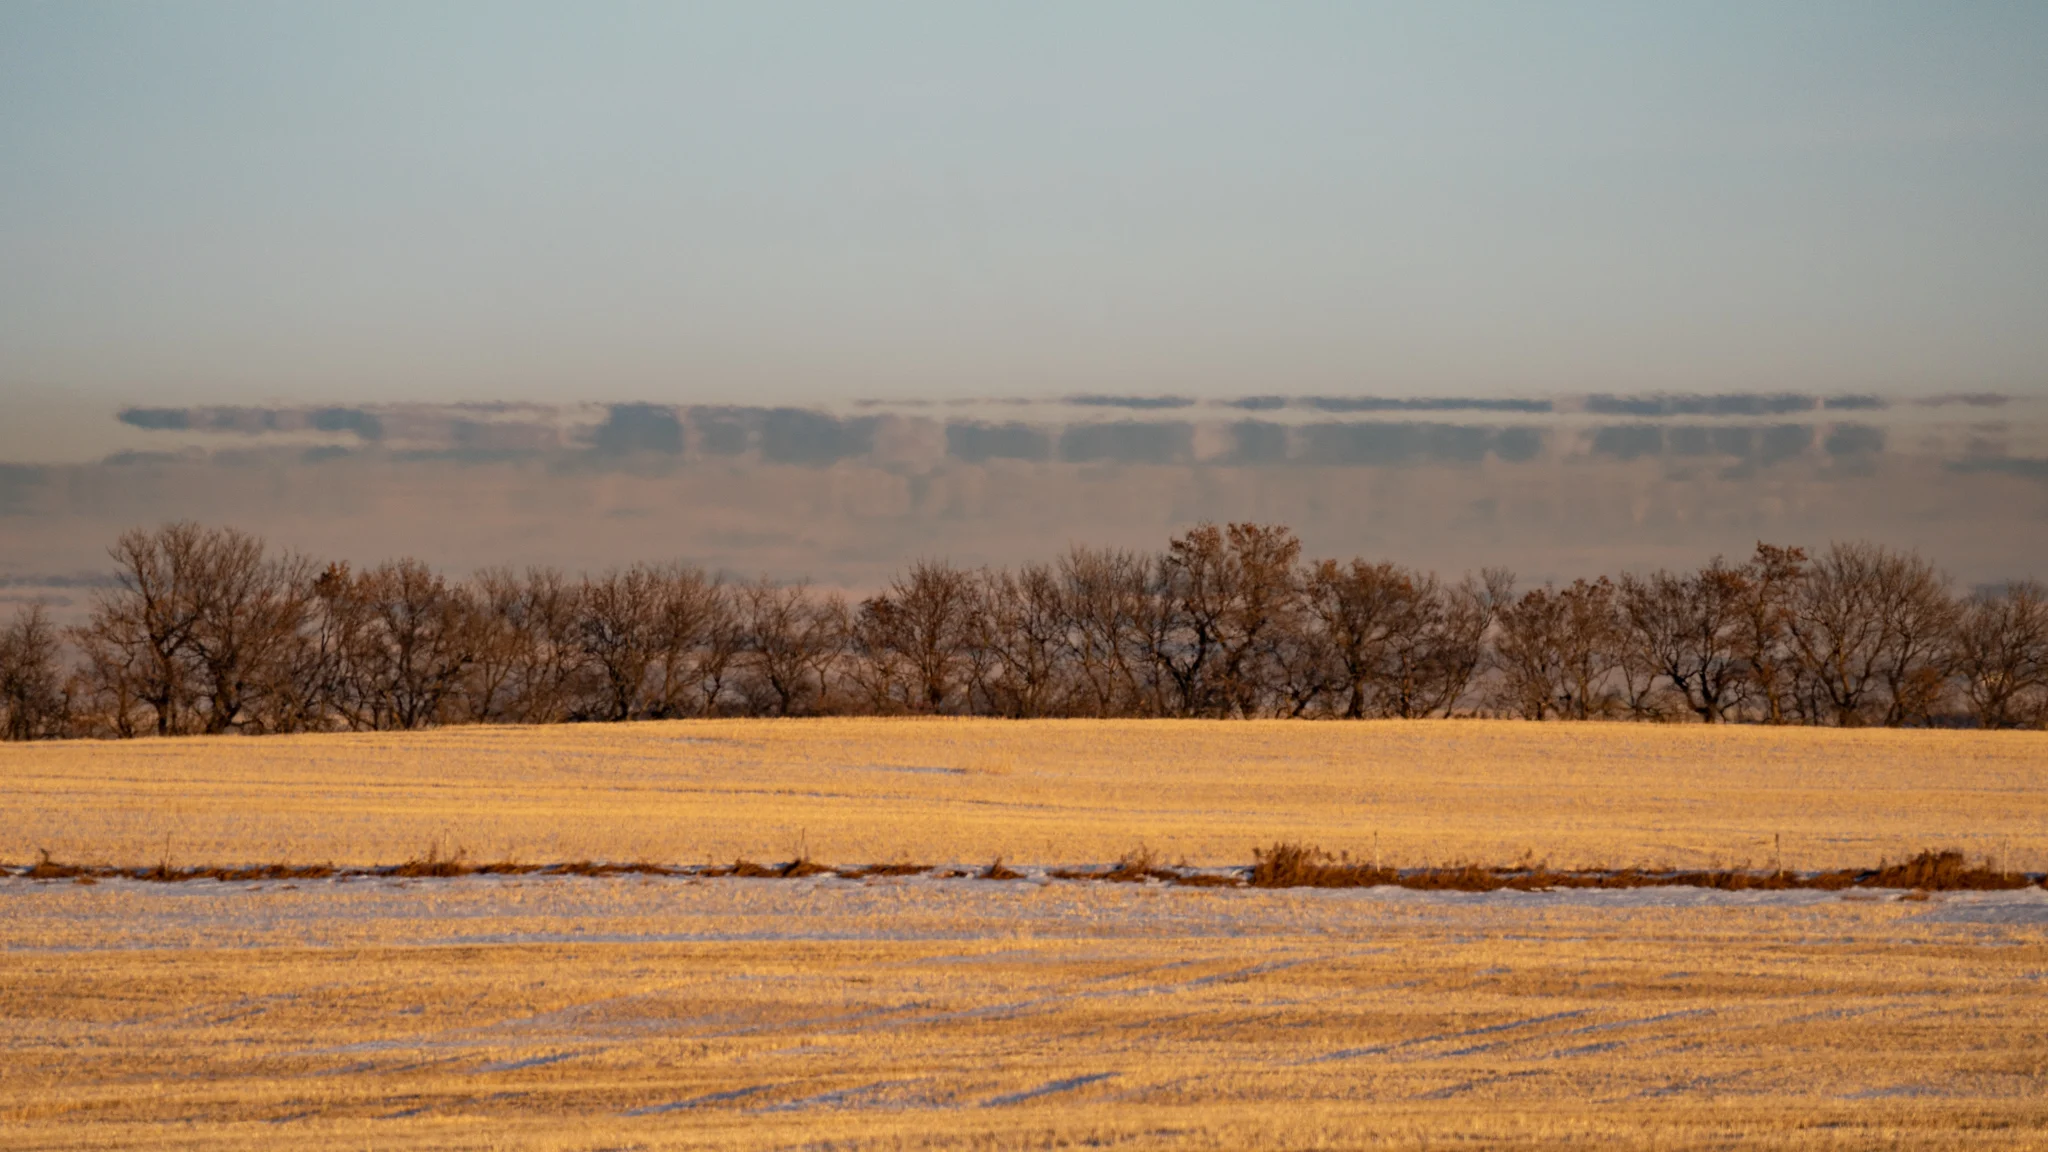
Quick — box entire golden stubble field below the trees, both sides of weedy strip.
[0,722,2048,1150]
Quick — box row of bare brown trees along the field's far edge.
[0,523,2048,740]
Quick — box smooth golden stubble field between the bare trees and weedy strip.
[0,719,2048,871]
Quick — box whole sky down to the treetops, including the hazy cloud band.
[0,0,2048,590]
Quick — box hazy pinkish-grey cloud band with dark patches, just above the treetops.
[0,396,2048,605]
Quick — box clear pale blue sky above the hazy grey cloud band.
[0,0,2048,402]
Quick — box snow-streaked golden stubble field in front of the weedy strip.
[0,875,2048,1152]
